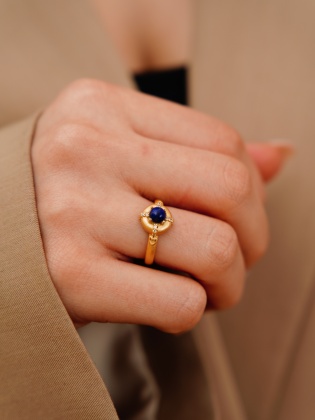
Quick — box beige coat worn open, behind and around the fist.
[0,0,315,420]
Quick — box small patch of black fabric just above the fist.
[134,67,188,105]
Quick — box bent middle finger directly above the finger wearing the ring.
[118,140,268,266]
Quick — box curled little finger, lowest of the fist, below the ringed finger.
[68,258,206,333]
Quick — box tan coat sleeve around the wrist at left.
[0,115,118,420]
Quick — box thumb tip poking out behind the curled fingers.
[246,140,295,181]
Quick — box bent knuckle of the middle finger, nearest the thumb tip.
[223,159,252,206]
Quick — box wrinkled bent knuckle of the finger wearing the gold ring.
[206,222,239,271]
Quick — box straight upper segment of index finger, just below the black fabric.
[121,84,244,155]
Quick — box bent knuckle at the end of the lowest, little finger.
[163,282,206,334]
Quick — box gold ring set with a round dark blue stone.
[140,200,174,265]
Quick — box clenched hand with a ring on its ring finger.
[32,80,288,332]
